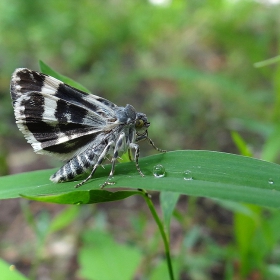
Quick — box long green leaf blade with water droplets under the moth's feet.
[0,151,280,207]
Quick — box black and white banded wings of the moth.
[11,68,117,160]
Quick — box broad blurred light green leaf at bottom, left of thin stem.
[78,231,142,280]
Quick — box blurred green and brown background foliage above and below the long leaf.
[0,0,280,279]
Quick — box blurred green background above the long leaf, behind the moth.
[0,0,280,279]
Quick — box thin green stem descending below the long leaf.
[142,190,175,280]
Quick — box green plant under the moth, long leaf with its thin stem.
[0,63,280,279]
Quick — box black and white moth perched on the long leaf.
[10,68,166,188]
